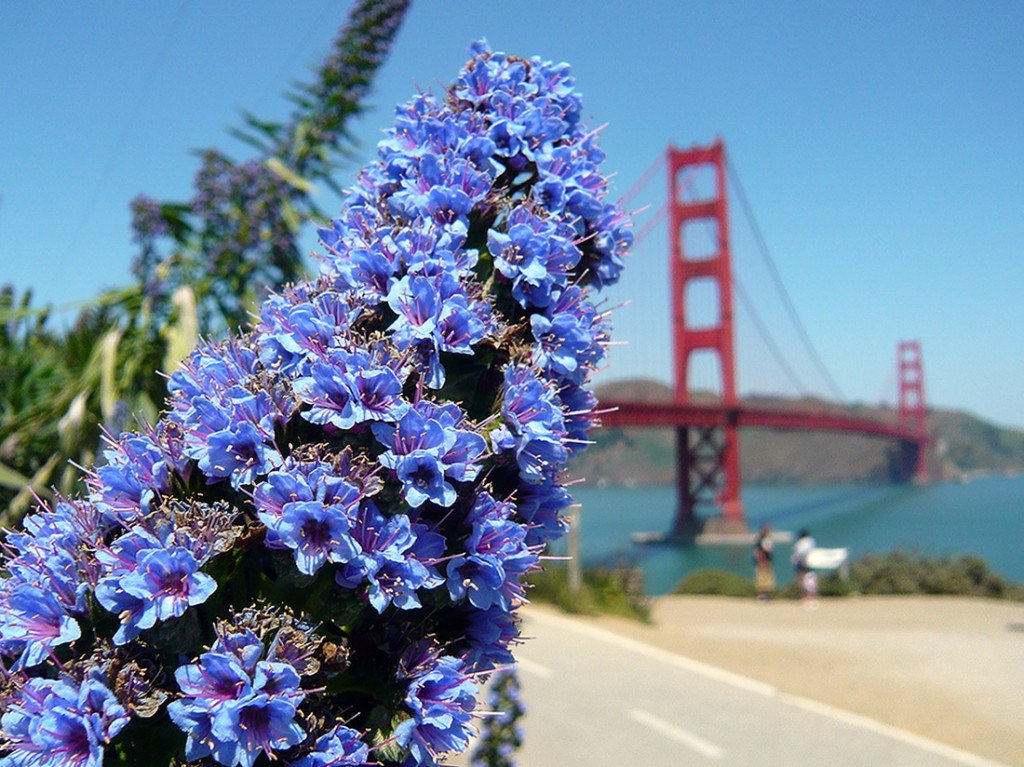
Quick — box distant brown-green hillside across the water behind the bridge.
[570,380,1024,484]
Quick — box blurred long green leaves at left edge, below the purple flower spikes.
[0,287,169,524]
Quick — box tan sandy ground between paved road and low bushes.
[580,596,1024,765]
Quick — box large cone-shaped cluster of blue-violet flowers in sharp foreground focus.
[0,45,631,767]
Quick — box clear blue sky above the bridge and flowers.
[0,0,1024,427]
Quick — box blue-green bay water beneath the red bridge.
[561,476,1024,594]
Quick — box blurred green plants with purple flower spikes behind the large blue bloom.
[0,0,409,526]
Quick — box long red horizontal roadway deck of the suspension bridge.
[601,399,921,444]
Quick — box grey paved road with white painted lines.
[501,610,996,767]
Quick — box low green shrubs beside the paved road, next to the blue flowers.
[528,564,650,623]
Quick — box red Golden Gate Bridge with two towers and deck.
[601,140,929,540]
